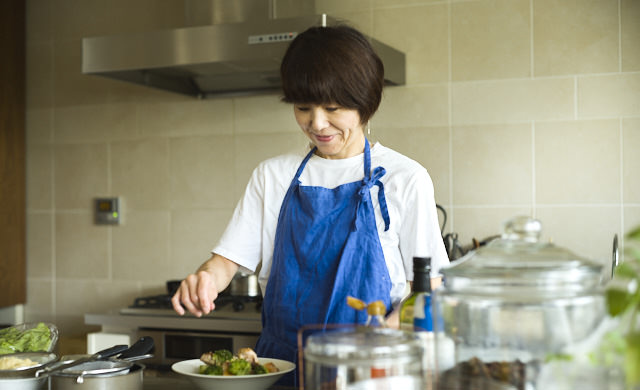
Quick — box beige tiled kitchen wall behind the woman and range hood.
[26,0,640,334]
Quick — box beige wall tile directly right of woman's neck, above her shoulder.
[372,127,451,203]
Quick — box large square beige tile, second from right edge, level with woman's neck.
[535,120,621,204]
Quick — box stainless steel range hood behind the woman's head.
[82,14,405,98]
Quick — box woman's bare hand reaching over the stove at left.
[171,254,238,317]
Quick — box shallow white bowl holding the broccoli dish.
[171,358,296,390]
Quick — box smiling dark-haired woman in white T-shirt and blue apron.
[172,26,448,384]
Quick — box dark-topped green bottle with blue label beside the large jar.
[400,257,433,332]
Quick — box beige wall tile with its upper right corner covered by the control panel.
[55,212,111,279]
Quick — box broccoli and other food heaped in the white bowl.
[199,348,278,375]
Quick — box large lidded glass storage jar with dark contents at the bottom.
[433,217,606,390]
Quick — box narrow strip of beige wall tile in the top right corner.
[620,0,640,72]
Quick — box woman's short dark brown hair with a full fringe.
[280,25,384,124]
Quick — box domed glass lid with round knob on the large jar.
[441,217,602,299]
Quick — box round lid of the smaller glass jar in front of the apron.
[304,327,422,364]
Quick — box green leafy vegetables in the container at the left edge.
[0,322,51,355]
